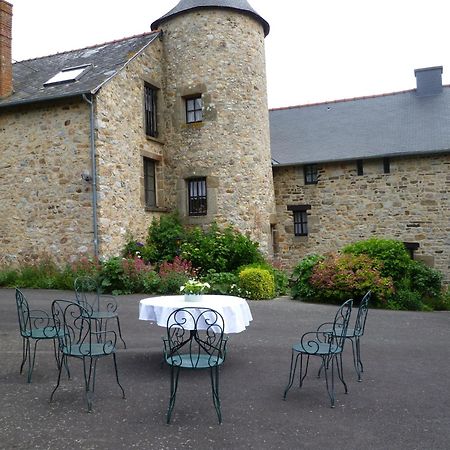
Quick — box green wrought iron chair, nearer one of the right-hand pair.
[283,299,353,408]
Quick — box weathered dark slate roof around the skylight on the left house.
[0,32,158,108]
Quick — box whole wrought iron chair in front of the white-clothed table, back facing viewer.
[163,307,227,423]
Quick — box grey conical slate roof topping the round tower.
[152,0,270,36]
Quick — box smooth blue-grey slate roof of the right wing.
[269,86,450,165]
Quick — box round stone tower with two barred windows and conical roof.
[152,0,275,255]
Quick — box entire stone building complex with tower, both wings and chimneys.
[0,0,450,281]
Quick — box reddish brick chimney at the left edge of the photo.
[0,0,13,98]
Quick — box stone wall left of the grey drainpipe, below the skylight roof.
[0,100,93,264]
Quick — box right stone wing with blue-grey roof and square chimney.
[270,67,450,282]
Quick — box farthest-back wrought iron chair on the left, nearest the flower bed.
[74,276,127,348]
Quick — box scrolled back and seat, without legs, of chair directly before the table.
[167,307,225,369]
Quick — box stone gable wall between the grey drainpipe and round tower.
[96,40,166,256]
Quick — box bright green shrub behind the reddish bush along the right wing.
[342,238,411,283]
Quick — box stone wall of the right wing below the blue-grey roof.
[274,154,450,282]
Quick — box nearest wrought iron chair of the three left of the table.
[50,300,125,412]
